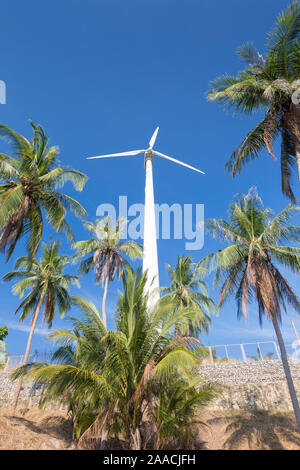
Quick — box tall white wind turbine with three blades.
[88,127,204,309]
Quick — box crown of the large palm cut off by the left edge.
[0,121,87,260]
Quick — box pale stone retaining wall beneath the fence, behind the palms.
[0,359,300,410]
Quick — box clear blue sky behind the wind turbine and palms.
[0,0,300,360]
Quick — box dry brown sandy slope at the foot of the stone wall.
[0,409,300,450]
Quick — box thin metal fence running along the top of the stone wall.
[0,340,300,371]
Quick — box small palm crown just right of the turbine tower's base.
[161,256,217,336]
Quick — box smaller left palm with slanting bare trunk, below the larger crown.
[3,240,79,411]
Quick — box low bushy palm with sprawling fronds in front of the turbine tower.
[15,268,215,449]
